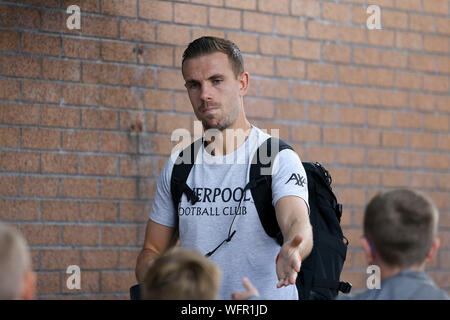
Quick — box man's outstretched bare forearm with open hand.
[275,196,313,287]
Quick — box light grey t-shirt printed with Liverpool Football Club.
[150,127,308,300]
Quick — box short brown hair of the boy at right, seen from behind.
[364,189,439,268]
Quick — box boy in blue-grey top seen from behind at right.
[340,189,448,300]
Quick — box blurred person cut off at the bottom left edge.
[0,222,36,300]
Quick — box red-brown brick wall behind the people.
[0,0,450,299]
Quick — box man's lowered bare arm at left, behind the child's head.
[136,219,175,283]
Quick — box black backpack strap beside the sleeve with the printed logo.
[249,137,293,243]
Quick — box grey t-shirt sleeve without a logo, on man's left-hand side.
[150,157,177,227]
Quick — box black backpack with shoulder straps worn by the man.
[170,137,352,300]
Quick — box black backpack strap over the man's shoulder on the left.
[170,139,203,221]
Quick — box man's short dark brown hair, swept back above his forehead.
[182,37,245,78]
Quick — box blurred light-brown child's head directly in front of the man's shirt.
[142,248,221,300]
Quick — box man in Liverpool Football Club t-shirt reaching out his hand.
[136,37,313,299]
